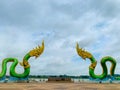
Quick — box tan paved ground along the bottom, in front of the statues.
[0,83,120,90]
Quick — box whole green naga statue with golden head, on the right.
[76,43,116,79]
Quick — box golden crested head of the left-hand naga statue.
[29,41,44,58]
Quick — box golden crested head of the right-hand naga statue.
[76,43,92,59]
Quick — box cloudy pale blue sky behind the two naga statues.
[0,0,120,76]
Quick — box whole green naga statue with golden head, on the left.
[0,41,44,78]
